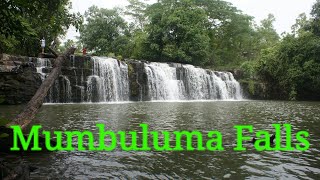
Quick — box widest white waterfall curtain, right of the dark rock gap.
[145,63,242,100]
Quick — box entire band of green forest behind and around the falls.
[0,0,320,100]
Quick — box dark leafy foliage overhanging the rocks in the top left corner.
[0,0,82,56]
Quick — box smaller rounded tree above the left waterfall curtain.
[80,6,130,55]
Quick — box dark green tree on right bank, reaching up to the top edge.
[252,0,320,100]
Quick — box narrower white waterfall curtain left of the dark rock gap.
[87,57,129,102]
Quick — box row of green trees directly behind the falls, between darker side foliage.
[61,0,279,69]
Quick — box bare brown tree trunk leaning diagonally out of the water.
[6,48,75,129]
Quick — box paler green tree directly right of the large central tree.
[195,0,254,67]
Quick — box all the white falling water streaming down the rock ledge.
[37,57,242,103]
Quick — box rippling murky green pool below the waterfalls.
[0,101,320,179]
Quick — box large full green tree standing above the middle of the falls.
[145,1,209,65]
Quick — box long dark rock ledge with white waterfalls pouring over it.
[0,55,242,104]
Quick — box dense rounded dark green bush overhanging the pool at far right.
[257,32,320,100]
